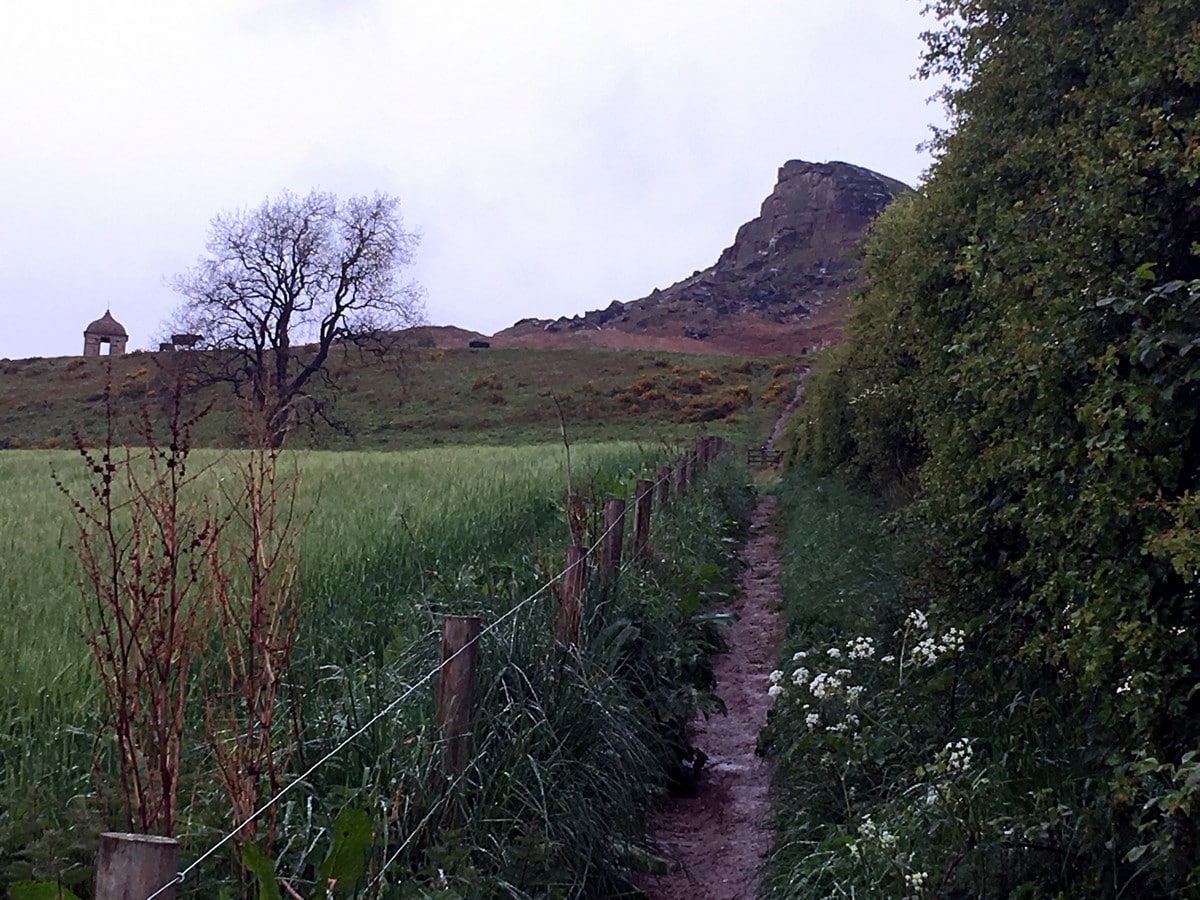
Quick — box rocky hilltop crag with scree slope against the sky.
[496,160,911,352]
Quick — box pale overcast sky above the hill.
[0,0,943,359]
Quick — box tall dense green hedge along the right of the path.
[796,0,1200,895]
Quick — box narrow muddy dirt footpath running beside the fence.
[640,497,781,900]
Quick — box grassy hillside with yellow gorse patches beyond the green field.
[0,347,799,450]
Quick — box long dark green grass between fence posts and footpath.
[258,461,750,898]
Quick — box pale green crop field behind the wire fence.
[0,443,646,798]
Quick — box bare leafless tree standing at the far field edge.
[173,191,424,446]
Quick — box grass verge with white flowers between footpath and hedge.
[761,468,1108,899]
